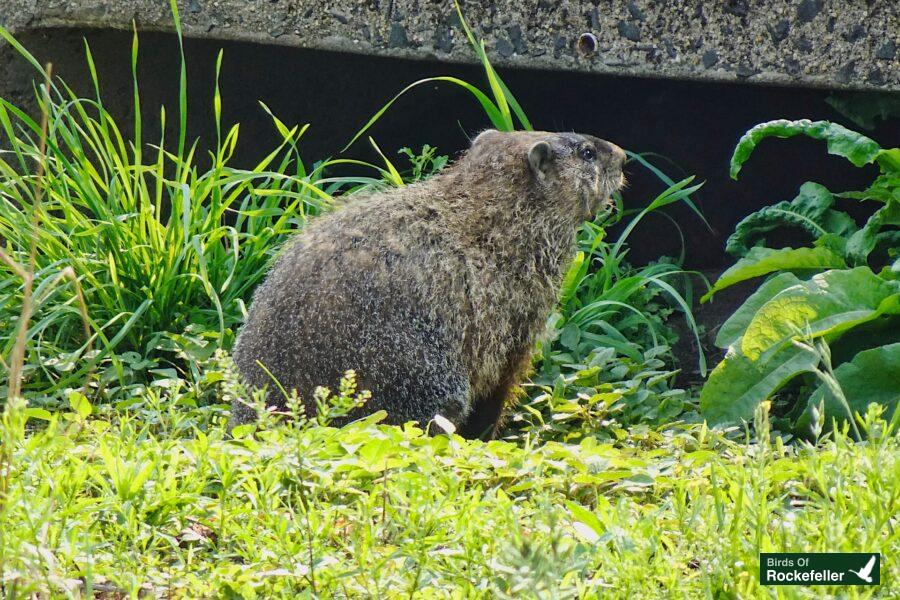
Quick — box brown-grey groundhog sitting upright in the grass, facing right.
[232,130,625,437]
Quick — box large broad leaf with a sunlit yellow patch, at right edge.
[741,267,900,360]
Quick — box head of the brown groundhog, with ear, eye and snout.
[469,129,625,220]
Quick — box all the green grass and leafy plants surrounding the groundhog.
[0,4,900,598]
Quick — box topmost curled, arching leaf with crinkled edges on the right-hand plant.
[731,119,890,179]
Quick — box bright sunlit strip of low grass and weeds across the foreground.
[0,375,900,598]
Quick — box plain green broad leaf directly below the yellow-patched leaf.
[700,345,819,424]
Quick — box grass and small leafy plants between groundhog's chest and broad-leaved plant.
[504,155,706,441]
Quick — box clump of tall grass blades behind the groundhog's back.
[0,32,358,401]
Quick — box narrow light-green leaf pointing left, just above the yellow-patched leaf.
[700,246,846,302]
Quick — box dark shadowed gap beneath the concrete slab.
[0,29,900,269]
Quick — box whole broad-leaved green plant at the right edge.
[700,121,900,430]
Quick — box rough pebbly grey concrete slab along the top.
[0,0,900,90]
